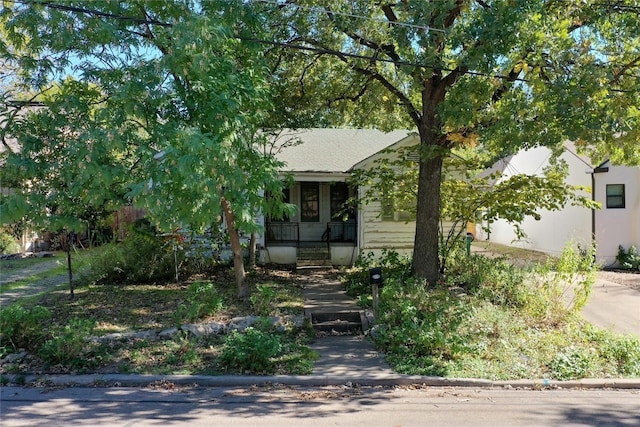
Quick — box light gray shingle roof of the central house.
[276,128,412,172]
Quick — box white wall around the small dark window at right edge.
[595,162,640,265]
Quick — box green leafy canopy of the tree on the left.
[0,1,282,237]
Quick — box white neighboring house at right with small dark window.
[477,142,640,266]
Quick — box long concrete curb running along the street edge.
[2,374,640,390]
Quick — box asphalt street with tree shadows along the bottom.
[0,384,640,427]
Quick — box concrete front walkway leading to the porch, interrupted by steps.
[298,269,396,380]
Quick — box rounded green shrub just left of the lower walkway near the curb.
[220,327,283,374]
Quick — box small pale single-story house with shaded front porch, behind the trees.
[258,129,419,265]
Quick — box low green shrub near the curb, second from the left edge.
[38,319,95,368]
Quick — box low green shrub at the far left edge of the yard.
[0,305,51,350]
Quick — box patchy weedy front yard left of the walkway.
[0,268,316,375]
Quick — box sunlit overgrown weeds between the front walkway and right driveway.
[346,247,640,379]
